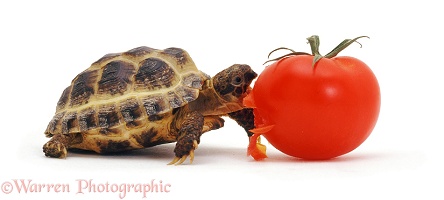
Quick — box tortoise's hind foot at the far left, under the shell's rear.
[43,134,72,158]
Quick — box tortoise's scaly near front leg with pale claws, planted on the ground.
[168,112,204,165]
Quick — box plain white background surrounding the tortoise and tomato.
[0,0,444,199]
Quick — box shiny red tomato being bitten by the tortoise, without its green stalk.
[244,36,381,160]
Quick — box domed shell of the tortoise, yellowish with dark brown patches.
[45,47,208,153]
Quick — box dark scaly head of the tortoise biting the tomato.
[213,64,257,104]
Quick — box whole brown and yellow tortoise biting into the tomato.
[43,46,257,164]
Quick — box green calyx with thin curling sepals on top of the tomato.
[264,35,369,67]
